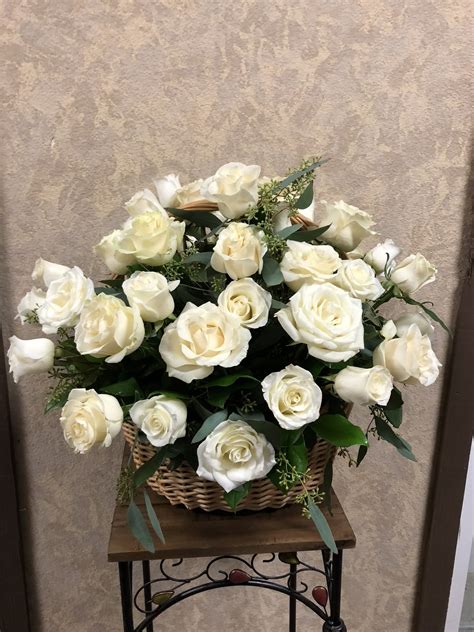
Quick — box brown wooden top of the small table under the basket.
[108,492,356,562]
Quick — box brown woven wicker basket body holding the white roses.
[122,421,336,511]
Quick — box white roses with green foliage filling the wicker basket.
[8,159,446,548]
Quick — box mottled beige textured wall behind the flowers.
[0,0,470,632]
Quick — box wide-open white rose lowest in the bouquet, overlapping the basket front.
[196,420,276,492]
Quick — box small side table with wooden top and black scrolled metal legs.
[108,492,356,632]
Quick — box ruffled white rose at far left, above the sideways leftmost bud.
[37,266,94,334]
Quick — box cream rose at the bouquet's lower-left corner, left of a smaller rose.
[60,388,123,454]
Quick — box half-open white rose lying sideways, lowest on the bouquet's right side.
[334,366,393,406]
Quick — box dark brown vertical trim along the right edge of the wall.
[413,139,474,632]
